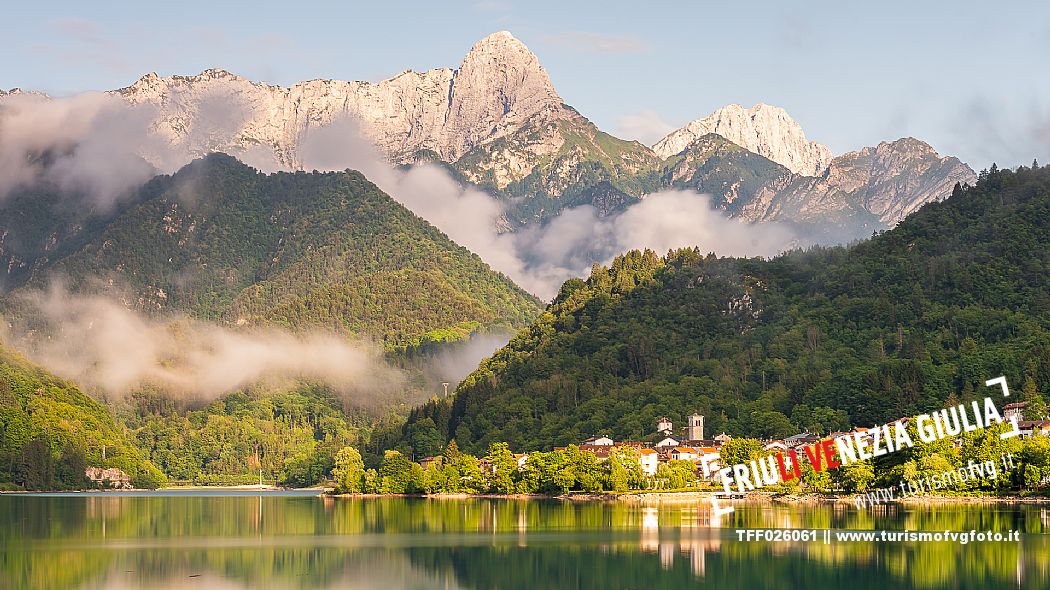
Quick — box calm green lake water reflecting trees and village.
[0,492,1050,590]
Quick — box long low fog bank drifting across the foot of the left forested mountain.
[4,287,404,405]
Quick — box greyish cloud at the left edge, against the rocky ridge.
[0,89,280,209]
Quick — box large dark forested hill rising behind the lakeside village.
[395,165,1050,452]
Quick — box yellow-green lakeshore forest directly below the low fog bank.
[118,384,369,487]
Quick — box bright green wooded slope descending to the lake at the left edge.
[0,340,163,489]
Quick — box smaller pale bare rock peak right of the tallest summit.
[653,103,832,176]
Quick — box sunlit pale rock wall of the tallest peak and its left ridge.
[116,31,574,167]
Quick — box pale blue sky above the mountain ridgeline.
[0,0,1050,169]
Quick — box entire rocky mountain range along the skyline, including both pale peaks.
[112,31,975,230]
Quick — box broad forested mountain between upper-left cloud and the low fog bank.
[18,154,540,349]
